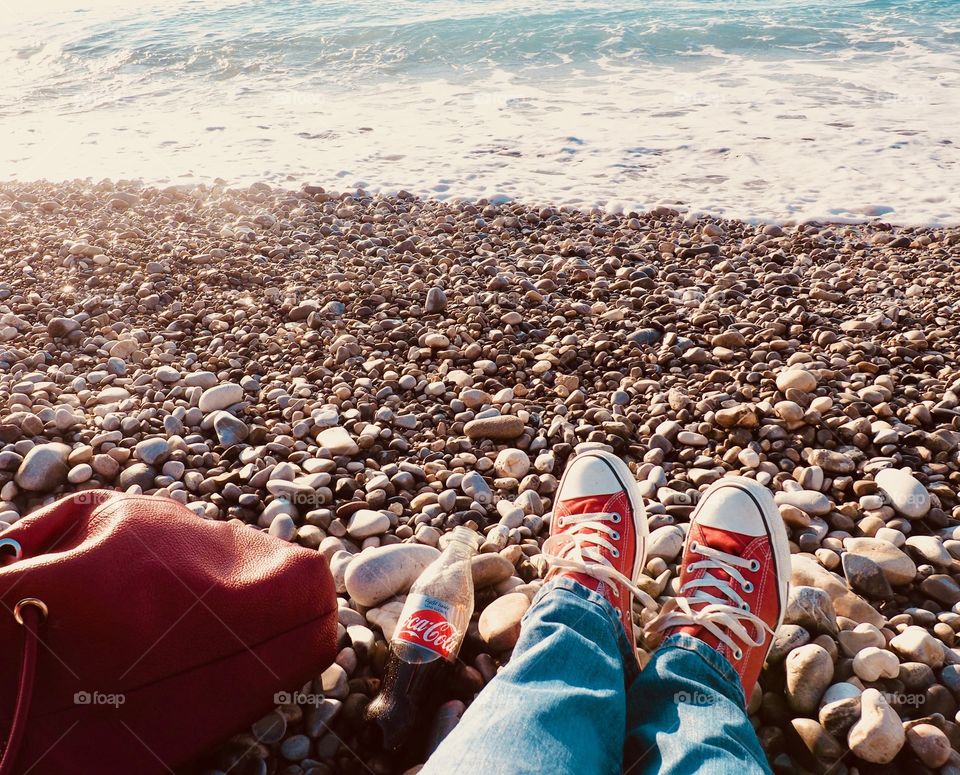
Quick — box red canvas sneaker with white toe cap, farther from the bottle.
[647,476,790,699]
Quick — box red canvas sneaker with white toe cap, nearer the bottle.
[543,450,652,650]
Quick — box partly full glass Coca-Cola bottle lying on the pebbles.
[364,527,477,752]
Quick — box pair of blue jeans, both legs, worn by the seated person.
[420,577,770,775]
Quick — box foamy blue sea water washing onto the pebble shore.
[0,0,960,223]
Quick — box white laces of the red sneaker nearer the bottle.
[543,512,657,609]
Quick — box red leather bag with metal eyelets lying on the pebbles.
[0,490,337,775]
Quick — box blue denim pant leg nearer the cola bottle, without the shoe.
[420,578,635,775]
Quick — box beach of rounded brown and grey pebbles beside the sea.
[0,181,960,775]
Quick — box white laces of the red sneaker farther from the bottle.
[648,543,773,659]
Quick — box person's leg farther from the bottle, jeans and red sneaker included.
[624,477,790,775]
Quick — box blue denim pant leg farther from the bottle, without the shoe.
[624,634,770,775]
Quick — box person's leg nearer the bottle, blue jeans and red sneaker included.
[421,451,647,775]
